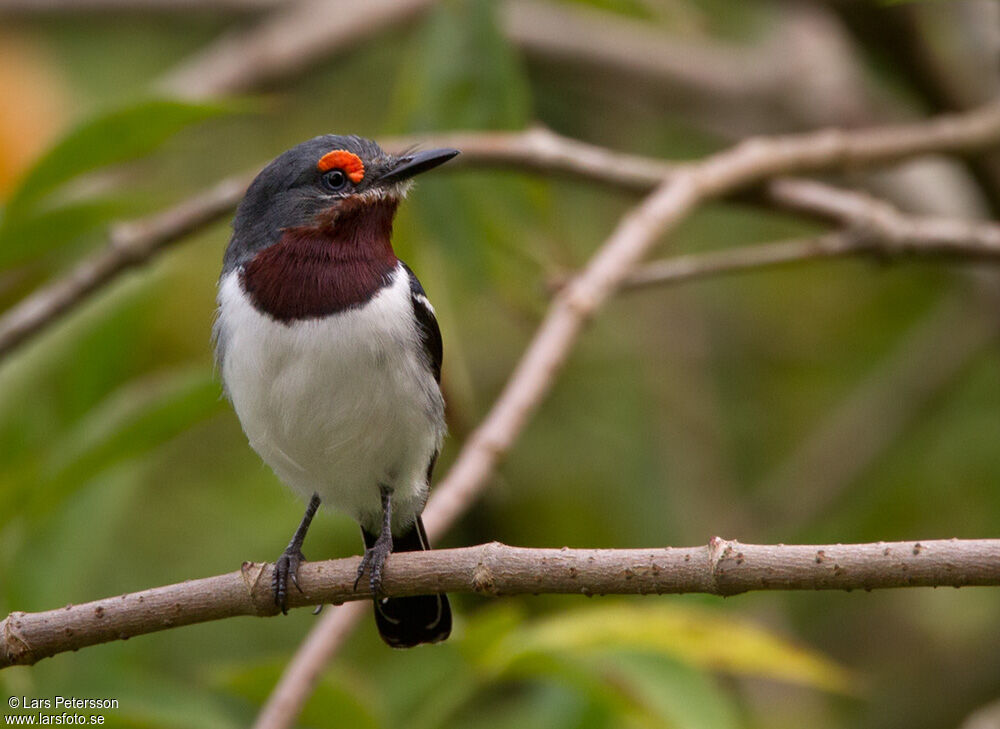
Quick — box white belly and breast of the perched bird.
[217,266,444,533]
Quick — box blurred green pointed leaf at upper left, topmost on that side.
[5,99,229,224]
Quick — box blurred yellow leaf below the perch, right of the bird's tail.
[482,603,854,693]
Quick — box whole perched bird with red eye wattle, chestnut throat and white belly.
[214,135,458,648]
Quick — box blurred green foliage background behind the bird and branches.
[0,0,1000,729]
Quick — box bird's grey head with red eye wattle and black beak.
[223,134,458,272]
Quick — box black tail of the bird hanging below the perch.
[361,516,451,648]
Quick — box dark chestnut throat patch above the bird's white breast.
[240,198,399,323]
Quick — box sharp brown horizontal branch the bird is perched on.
[0,537,1000,667]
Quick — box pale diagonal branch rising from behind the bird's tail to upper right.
[254,105,1000,729]
